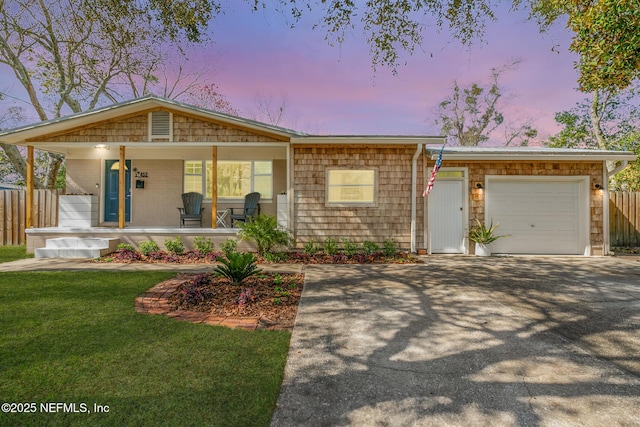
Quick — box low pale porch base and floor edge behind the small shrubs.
[26,227,256,253]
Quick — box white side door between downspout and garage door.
[427,176,467,254]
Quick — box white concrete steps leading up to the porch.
[34,237,120,258]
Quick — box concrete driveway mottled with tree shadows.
[272,257,640,426]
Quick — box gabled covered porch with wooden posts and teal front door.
[2,96,297,252]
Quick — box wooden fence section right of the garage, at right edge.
[609,191,640,247]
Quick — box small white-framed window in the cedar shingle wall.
[327,169,377,206]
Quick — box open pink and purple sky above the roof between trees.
[191,3,585,144]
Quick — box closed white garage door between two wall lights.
[485,178,589,255]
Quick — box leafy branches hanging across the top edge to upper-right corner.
[236,0,640,92]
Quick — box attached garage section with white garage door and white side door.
[424,146,637,255]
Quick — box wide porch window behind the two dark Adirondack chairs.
[184,160,273,199]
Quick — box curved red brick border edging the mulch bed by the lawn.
[135,277,293,331]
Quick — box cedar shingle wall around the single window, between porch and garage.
[293,145,423,249]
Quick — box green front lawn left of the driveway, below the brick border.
[0,272,290,426]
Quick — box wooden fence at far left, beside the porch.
[0,190,60,245]
